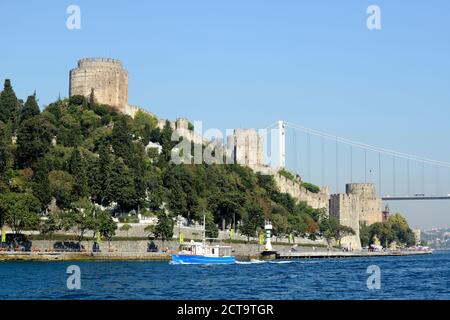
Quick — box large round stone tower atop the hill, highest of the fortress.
[69,58,128,112]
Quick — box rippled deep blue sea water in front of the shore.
[0,251,450,300]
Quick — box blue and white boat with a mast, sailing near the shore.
[171,217,236,264]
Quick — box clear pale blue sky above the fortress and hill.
[0,0,450,228]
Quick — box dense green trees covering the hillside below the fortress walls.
[0,81,358,239]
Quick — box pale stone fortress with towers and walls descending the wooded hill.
[69,58,383,250]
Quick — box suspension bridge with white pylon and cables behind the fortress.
[267,121,450,201]
